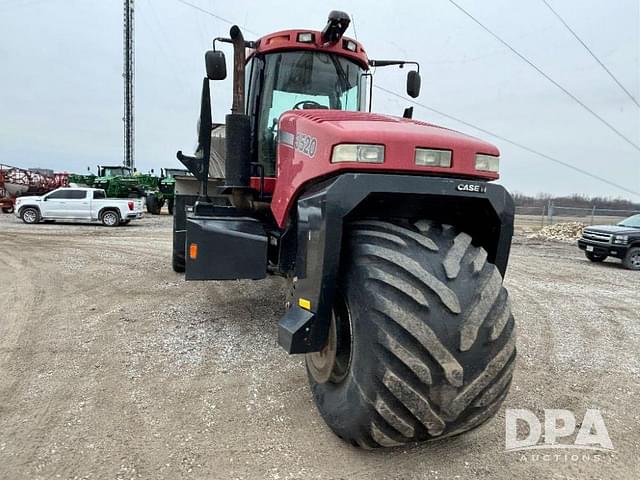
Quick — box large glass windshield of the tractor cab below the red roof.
[257,51,362,176]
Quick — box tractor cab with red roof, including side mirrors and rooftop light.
[198,11,420,184]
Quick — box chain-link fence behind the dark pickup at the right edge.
[515,202,640,230]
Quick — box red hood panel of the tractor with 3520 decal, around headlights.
[271,110,499,226]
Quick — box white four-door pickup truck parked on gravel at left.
[15,188,143,227]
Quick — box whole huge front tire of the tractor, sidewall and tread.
[307,220,516,448]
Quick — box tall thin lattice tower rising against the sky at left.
[122,0,136,171]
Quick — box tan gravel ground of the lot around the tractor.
[0,215,640,480]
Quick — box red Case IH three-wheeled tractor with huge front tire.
[173,11,516,448]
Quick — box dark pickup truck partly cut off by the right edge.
[578,214,640,270]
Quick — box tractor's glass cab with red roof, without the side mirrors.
[245,35,368,177]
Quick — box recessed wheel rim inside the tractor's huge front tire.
[306,294,353,383]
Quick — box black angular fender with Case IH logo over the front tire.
[278,173,514,353]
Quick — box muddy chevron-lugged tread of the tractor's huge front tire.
[308,220,516,447]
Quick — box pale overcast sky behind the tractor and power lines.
[0,0,640,201]
